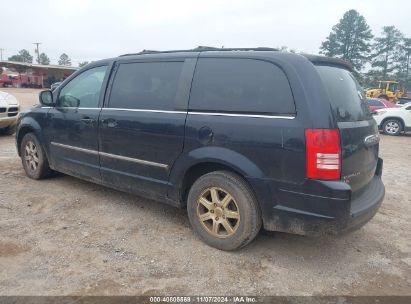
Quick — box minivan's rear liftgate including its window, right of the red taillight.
[316,65,379,192]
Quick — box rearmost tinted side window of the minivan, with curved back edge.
[189,58,295,114]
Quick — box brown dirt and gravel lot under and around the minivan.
[0,89,411,295]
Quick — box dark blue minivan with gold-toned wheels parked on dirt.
[16,48,385,250]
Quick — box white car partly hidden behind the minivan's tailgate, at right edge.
[374,102,411,135]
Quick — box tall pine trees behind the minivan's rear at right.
[320,9,411,89]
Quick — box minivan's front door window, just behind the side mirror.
[58,66,107,108]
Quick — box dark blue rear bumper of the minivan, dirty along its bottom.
[254,159,385,235]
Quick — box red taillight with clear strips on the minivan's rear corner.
[305,129,341,180]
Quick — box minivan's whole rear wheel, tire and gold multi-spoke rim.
[187,171,261,250]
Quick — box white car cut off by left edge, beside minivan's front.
[0,91,20,135]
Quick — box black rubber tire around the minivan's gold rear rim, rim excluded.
[187,171,261,250]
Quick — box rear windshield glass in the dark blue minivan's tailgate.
[316,65,371,121]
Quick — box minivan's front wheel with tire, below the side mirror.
[20,133,51,179]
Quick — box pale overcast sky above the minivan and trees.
[0,0,411,65]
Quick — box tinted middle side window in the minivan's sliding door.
[109,62,183,110]
